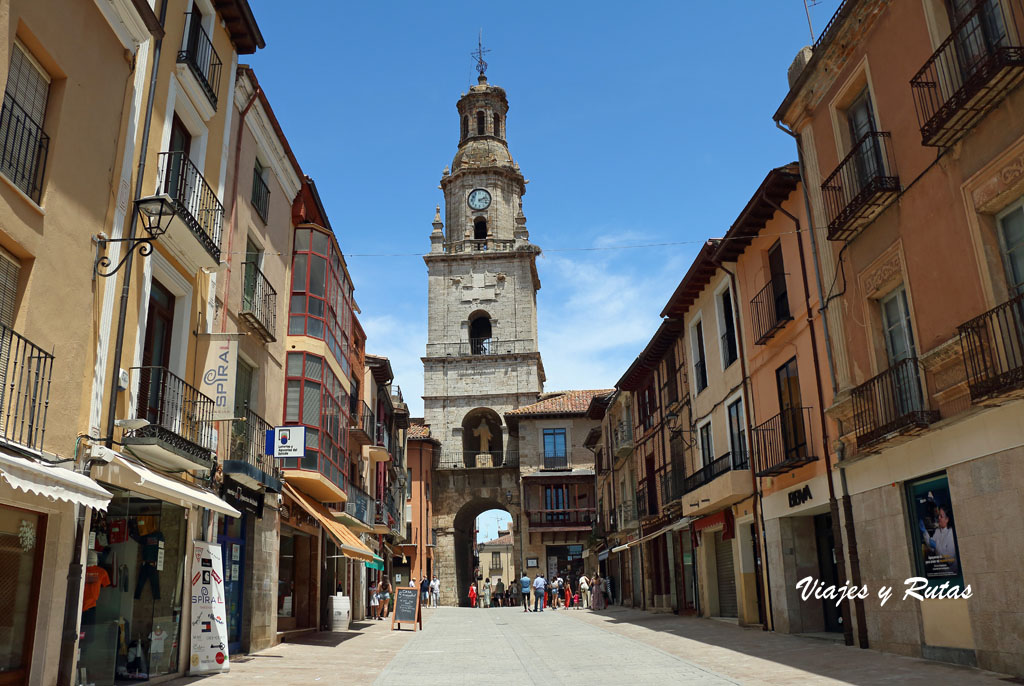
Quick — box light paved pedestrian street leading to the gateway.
[173,608,1007,686]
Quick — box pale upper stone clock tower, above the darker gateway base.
[423,69,544,469]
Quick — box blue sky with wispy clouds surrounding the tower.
[243,0,839,535]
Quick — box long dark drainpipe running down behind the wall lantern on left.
[57,0,167,686]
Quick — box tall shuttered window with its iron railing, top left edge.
[0,40,50,204]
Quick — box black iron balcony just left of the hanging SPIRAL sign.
[125,367,216,465]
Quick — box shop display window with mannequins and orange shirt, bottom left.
[78,484,188,686]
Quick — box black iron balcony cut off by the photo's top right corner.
[910,0,1024,147]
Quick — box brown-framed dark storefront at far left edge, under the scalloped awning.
[0,506,46,684]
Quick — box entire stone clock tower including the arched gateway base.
[423,69,544,605]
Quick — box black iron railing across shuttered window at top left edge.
[0,94,50,205]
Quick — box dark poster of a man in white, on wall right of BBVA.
[910,475,961,578]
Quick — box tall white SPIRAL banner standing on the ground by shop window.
[188,541,228,674]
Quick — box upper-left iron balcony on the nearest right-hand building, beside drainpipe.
[821,131,900,241]
